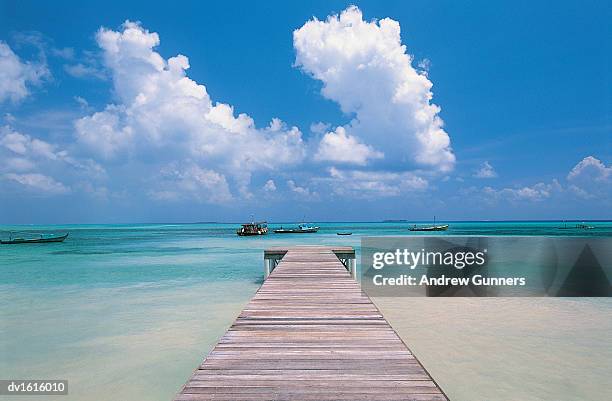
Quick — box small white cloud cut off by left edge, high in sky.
[0,41,49,103]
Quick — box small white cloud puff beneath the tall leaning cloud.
[314,127,383,165]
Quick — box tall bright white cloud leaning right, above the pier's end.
[293,6,455,171]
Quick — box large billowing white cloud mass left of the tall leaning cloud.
[75,21,305,200]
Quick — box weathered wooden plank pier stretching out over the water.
[175,246,448,401]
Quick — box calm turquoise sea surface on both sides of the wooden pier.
[0,222,612,401]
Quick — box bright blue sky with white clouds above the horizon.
[0,1,612,223]
